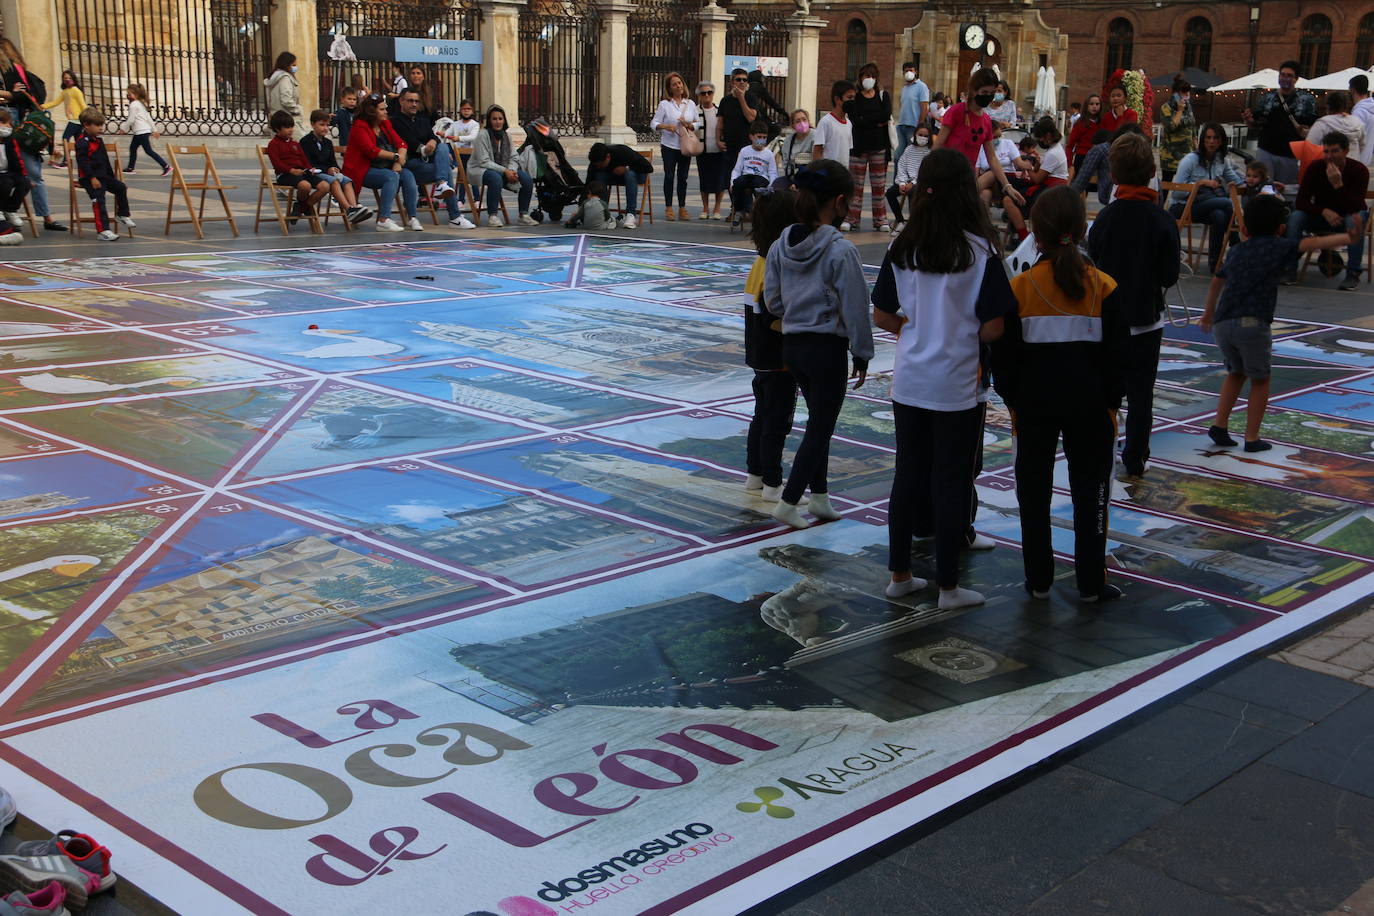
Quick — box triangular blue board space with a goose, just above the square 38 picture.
[236,382,537,479]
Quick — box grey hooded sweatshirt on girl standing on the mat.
[764,224,872,368]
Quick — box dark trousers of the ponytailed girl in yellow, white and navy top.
[1013,409,1117,595]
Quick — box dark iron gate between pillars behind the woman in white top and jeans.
[628,0,713,141]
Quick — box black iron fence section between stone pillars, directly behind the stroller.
[519,0,602,136]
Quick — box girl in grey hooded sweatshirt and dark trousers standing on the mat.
[764,159,872,527]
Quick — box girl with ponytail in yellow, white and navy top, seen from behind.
[992,185,1126,602]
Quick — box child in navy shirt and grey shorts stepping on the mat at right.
[1198,194,1364,452]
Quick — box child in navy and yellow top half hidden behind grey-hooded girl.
[745,190,797,503]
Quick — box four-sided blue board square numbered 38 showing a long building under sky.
[245,461,688,586]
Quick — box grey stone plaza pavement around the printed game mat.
[8,161,1374,916]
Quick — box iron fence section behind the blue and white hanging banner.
[315,0,482,117]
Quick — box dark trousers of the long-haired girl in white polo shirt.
[888,401,987,588]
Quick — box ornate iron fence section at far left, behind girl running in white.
[57,0,272,136]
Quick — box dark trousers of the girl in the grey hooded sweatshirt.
[782,332,849,505]
